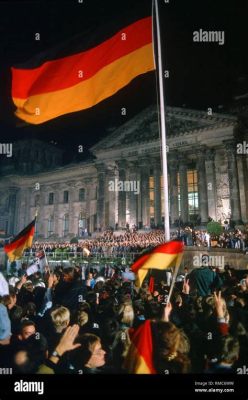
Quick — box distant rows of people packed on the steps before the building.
[16,228,248,257]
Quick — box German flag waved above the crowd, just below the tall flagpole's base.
[131,241,184,287]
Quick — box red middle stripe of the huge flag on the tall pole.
[12,17,152,99]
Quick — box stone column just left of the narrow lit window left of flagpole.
[140,158,150,227]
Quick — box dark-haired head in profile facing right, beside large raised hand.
[70,333,106,371]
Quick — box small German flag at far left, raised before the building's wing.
[4,218,36,262]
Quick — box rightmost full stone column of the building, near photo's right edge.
[224,141,241,222]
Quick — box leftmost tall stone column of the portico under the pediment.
[96,164,106,231]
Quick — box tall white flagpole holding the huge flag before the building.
[154,0,170,241]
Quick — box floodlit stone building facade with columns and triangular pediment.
[0,107,248,239]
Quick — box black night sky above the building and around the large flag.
[0,0,248,161]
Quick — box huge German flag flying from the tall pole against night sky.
[12,17,154,124]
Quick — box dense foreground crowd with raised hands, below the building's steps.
[0,260,248,374]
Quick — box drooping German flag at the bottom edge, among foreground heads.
[123,320,156,374]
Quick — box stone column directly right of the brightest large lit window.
[196,148,208,224]
